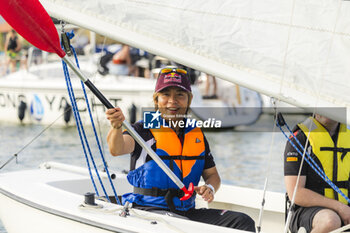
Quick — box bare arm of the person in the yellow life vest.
[284,176,350,224]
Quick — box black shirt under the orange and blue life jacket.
[123,121,215,170]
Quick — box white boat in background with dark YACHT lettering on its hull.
[0,58,261,128]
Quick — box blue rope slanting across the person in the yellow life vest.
[276,121,350,203]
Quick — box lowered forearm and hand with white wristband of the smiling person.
[194,166,221,203]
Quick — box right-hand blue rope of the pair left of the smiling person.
[71,46,121,205]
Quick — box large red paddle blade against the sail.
[0,0,65,58]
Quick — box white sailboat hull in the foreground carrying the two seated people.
[0,162,284,233]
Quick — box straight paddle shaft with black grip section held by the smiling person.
[62,55,185,189]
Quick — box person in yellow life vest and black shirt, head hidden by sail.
[284,114,350,233]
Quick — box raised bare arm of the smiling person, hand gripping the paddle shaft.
[106,108,135,156]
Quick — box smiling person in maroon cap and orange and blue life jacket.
[106,67,255,232]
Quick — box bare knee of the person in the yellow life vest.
[311,209,342,233]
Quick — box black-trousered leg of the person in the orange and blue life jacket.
[185,208,255,232]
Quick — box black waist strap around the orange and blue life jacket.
[134,187,184,212]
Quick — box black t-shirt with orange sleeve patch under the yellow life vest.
[284,125,339,184]
